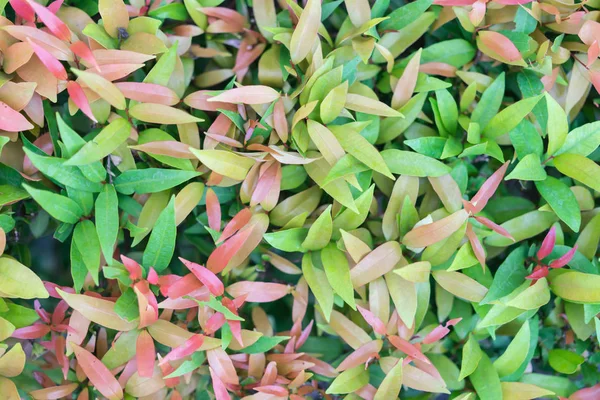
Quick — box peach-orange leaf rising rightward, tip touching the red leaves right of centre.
[402,210,469,248]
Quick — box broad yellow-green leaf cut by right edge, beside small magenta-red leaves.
[550,271,600,304]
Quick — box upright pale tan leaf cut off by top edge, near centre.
[289,0,321,64]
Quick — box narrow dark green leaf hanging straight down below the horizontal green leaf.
[94,184,119,264]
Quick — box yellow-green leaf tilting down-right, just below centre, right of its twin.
[321,243,356,309]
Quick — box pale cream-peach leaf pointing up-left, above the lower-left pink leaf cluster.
[56,289,137,331]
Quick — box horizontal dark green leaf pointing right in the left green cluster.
[114,168,200,194]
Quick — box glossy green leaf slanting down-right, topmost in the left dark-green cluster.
[23,147,102,192]
